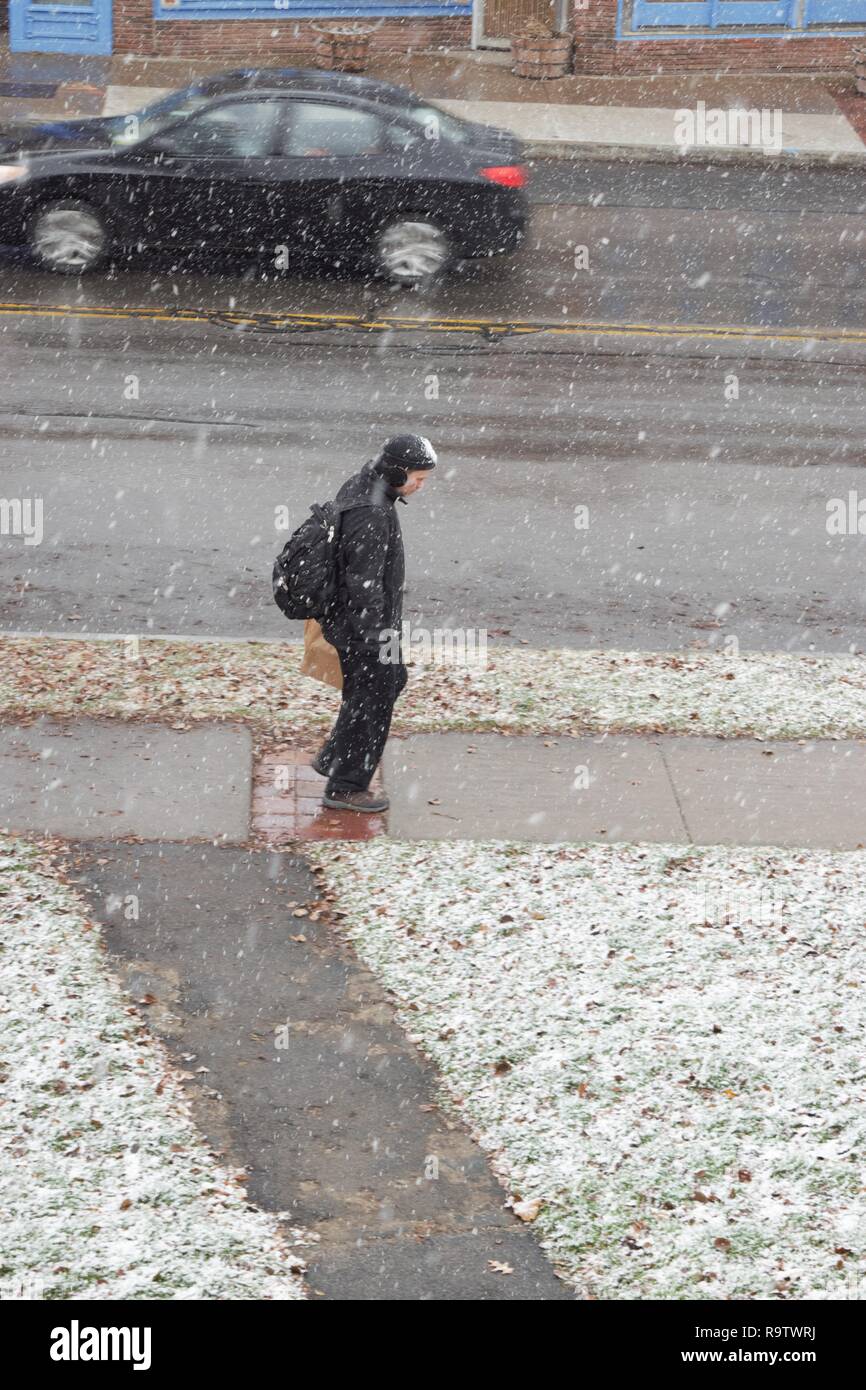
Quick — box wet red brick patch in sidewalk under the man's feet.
[252,748,386,845]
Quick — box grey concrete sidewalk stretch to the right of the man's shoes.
[384,734,866,849]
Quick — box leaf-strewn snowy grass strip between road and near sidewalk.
[0,637,866,738]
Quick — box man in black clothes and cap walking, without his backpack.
[313,435,436,812]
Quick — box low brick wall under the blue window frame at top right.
[573,0,866,76]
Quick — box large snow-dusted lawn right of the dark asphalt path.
[310,840,866,1300]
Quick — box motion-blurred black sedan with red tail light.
[0,68,527,285]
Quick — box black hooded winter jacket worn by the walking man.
[321,463,406,655]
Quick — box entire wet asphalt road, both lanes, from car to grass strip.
[0,164,866,652]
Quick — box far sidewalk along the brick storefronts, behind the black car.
[0,51,866,167]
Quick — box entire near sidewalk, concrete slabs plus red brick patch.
[0,717,866,849]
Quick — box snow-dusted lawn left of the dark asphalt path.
[0,837,304,1300]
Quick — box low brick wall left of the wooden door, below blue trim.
[114,0,471,65]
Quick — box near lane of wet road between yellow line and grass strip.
[0,318,866,652]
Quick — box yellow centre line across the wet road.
[0,300,866,345]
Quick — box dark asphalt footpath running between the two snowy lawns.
[70,842,574,1301]
